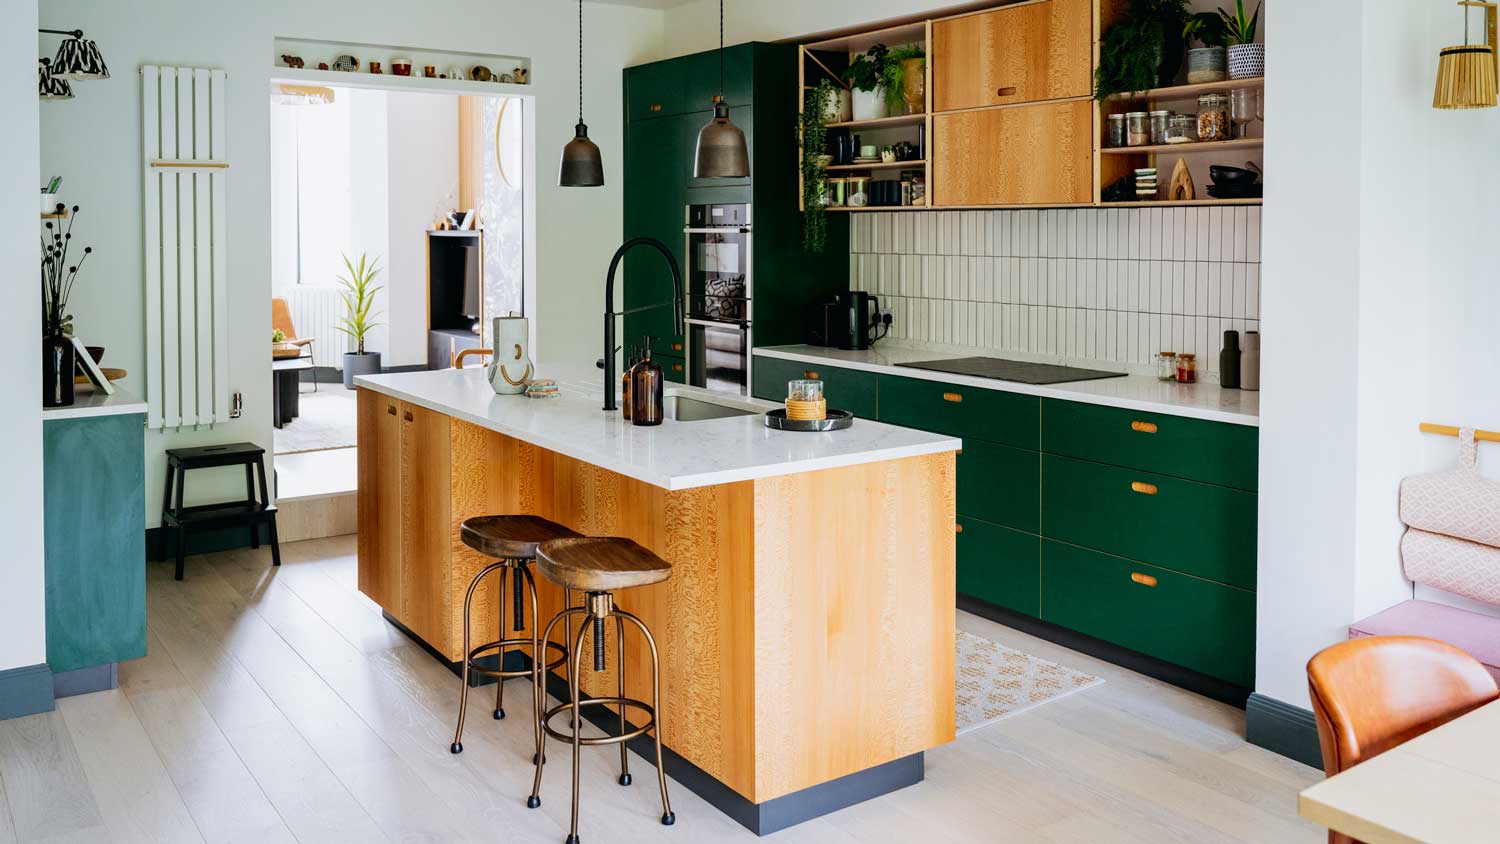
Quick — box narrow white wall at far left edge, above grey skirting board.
[0,0,46,670]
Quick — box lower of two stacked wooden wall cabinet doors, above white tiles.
[932,100,1094,205]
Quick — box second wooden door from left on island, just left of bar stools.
[392,402,450,660]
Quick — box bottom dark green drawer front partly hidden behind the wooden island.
[957,516,1041,616]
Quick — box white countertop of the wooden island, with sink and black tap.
[354,369,963,490]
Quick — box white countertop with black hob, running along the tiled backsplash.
[755,343,1260,426]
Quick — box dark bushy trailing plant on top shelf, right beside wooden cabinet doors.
[1094,0,1188,100]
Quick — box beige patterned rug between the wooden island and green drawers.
[957,630,1104,735]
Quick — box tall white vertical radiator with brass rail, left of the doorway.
[141,66,228,429]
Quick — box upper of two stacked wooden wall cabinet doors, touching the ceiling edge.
[933,0,1094,111]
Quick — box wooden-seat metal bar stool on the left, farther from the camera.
[449,516,578,763]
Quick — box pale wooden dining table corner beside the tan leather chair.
[1298,702,1500,844]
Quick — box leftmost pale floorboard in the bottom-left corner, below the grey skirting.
[0,712,104,844]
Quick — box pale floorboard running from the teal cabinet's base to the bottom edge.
[57,690,203,844]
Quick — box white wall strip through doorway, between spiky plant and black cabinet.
[384,93,459,366]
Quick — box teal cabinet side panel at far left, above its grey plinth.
[42,411,146,673]
